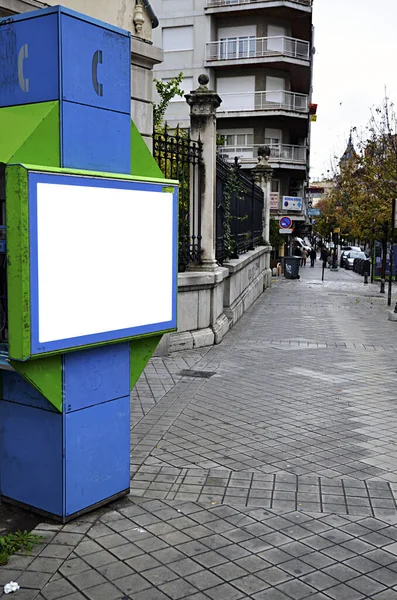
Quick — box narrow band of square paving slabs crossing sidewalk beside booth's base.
[131,465,397,517]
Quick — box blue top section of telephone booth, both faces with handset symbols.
[0,6,131,114]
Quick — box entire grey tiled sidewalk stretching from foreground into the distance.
[0,265,397,600]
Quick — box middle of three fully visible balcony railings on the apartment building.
[218,90,308,113]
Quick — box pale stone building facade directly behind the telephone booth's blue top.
[0,0,163,147]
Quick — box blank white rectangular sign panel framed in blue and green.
[37,183,173,343]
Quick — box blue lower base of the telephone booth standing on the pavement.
[0,360,130,521]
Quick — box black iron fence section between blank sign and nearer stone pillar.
[153,125,203,271]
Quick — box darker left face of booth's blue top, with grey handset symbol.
[0,11,59,107]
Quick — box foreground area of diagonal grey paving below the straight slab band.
[0,496,397,600]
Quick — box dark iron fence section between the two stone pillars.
[216,155,264,263]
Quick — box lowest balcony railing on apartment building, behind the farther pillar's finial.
[218,144,306,165]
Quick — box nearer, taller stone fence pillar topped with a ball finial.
[185,75,222,271]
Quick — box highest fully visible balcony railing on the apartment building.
[206,35,310,61]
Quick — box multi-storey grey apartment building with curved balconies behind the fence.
[152,0,313,221]
